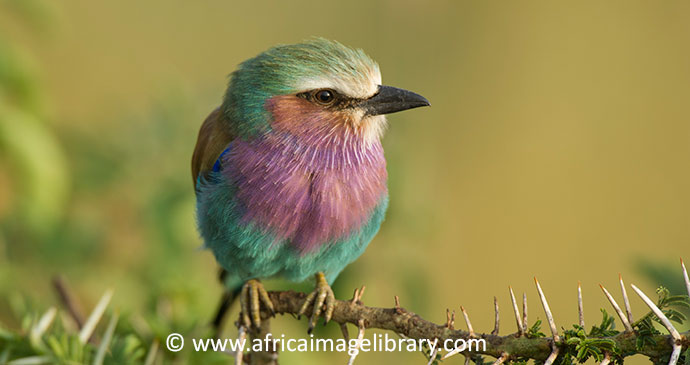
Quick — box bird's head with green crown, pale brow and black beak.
[222,38,429,142]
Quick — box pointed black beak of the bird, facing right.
[359,85,431,115]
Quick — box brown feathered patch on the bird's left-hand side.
[192,108,235,187]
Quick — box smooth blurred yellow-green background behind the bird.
[0,0,690,364]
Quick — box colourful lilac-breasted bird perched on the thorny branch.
[192,38,430,332]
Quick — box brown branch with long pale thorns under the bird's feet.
[232,258,690,365]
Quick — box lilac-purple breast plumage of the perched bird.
[223,128,387,254]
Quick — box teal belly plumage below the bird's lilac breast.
[197,175,388,283]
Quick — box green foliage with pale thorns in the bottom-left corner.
[0,290,229,365]
